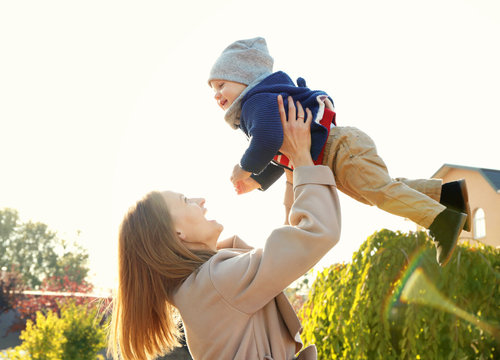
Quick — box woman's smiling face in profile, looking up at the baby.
[162,191,223,251]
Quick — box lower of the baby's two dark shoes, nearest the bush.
[429,208,467,266]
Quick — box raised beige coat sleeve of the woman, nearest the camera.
[209,166,340,314]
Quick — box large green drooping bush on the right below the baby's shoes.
[299,230,500,359]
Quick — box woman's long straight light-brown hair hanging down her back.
[108,192,214,360]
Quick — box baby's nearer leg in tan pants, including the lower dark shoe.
[324,127,467,266]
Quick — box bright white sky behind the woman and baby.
[0,0,500,286]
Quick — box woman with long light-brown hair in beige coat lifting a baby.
[110,97,340,360]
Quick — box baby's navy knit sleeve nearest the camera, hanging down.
[240,93,283,174]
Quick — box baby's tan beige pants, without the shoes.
[323,126,445,228]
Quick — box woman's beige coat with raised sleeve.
[174,166,340,360]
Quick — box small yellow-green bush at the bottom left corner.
[9,302,106,360]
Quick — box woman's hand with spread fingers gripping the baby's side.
[278,95,314,167]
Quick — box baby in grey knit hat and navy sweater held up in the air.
[208,37,470,266]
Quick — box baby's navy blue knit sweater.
[239,71,333,188]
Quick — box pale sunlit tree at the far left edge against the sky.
[0,208,89,289]
